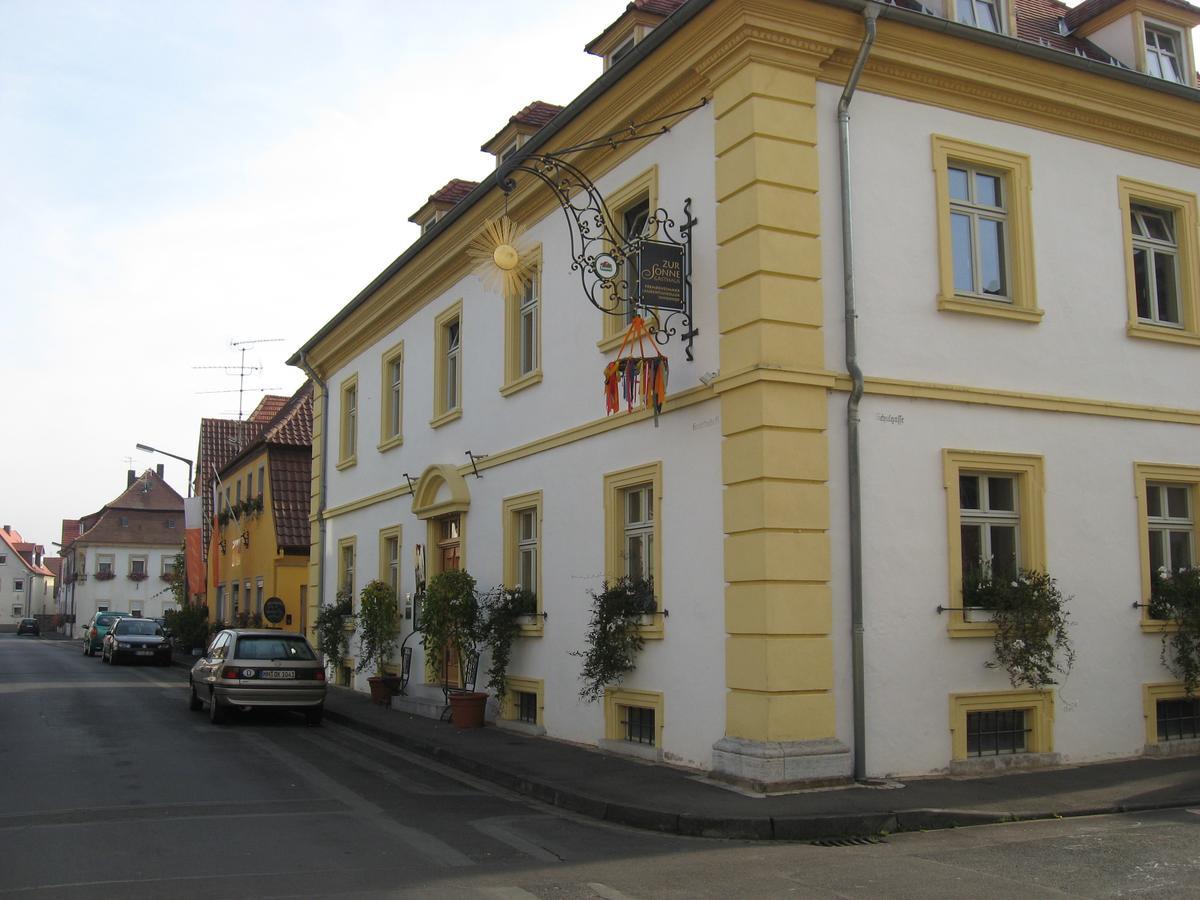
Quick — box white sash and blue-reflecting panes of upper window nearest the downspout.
[948,162,1012,302]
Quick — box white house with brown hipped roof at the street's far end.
[59,466,184,636]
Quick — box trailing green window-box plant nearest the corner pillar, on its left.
[571,576,658,702]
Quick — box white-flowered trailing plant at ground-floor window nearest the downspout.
[962,569,1075,690]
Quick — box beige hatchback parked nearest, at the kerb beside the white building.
[188,629,325,725]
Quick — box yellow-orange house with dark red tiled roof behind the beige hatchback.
[209,382,312,632]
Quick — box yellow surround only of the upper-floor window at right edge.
[1117,178,1200,347]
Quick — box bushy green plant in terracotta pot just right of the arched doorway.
[420,570,487,728]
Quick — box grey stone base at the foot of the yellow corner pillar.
[710,738,854,793]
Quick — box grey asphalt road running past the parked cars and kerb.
[0,635,1200,900]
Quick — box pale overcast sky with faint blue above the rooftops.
[0,0,1195,553]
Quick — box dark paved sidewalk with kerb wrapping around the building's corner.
[309,686,1200,840]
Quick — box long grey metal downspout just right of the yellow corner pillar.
[838,2,880,781]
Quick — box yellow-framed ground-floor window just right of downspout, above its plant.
[942,450,1045,637]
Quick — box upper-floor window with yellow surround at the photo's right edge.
[1118,179,1200,344]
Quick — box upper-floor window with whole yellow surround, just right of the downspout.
[932,134,1043,322]
